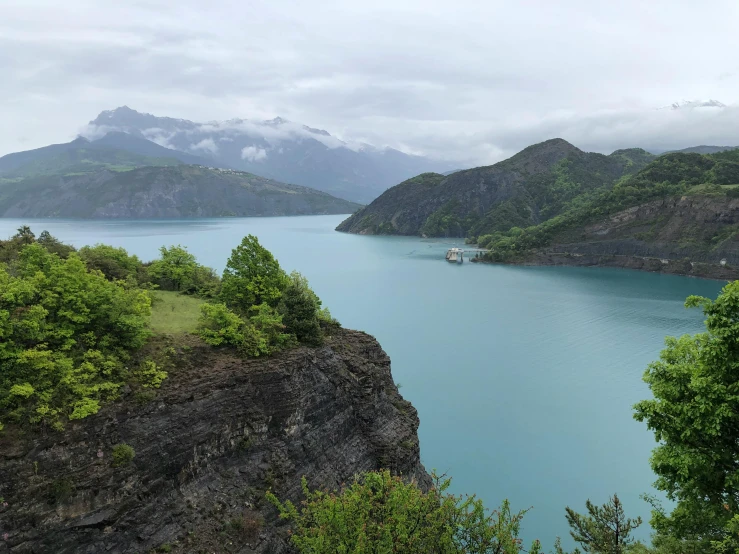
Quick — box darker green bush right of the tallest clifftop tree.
[279,271,322,346]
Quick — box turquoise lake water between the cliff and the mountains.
[0,216,722,547]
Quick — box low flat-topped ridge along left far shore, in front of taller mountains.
[0,165,360,218]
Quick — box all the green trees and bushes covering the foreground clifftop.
[0,227,338,430]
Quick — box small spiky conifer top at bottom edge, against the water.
[565,494,642,554]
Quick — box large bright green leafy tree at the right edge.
[634,282,739,552]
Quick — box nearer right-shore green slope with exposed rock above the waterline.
[478,150,739,279]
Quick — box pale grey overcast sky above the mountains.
[0,0,739,165]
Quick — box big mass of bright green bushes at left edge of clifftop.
[0,243,150,428]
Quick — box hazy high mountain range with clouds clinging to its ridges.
[85,106,454,202]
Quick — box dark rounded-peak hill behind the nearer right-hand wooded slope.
[337,139,654,237]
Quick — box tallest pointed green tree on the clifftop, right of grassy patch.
[220,235,288,314]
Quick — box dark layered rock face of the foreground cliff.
[0,330,429,554]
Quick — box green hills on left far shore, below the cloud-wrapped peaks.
[0,132,360,218]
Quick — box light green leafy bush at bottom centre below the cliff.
[267,470,540,554]
